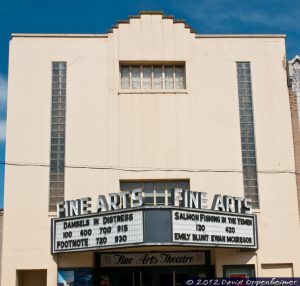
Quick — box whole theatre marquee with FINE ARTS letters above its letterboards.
[51,189,257,253]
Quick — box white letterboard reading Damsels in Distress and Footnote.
[52,211,143,253]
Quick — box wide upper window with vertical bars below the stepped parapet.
[120,64,185,90]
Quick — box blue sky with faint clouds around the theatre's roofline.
[0,0,300,208]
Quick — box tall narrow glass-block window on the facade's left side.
[49,62,67,211]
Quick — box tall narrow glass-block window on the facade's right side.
[237,62,259,208]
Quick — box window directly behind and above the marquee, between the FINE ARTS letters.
[120,180,190,206]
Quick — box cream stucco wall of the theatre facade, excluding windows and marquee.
[2,11,300,285]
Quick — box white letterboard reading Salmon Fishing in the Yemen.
[172,210,257,248]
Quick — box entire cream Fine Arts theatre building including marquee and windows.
[2,12,300,286]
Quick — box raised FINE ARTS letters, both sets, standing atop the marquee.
[57,191,252,217]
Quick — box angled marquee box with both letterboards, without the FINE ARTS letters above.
[52,207,257,253]
